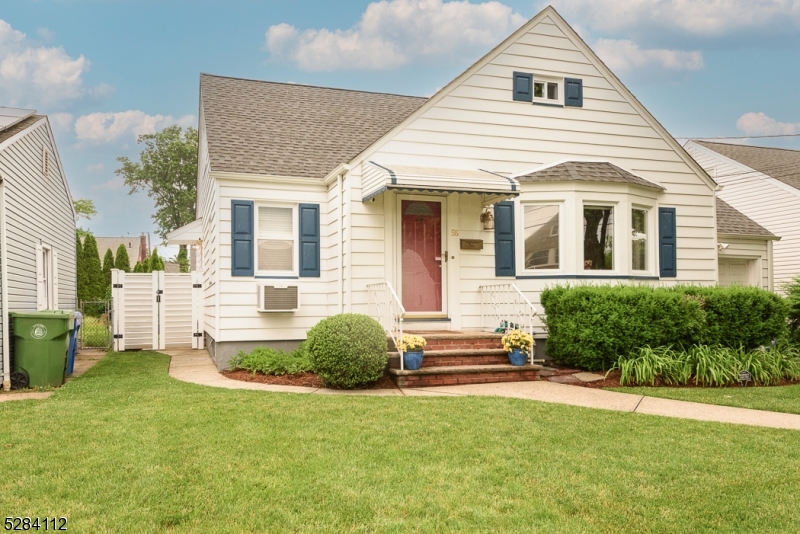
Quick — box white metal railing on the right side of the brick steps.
[478,284,536,363]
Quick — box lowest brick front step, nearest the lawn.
[389,364,542,388]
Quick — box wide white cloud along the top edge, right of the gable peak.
[547,0,800,36]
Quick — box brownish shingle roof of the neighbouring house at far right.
[695,140,800,193]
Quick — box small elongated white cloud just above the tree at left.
[75,110,195,143]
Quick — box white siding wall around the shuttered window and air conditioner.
[215,178,335,342]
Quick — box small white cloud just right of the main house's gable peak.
[592,39,704,72]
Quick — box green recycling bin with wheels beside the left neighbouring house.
[11,310,75,389]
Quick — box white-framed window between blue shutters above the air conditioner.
[256,205,297,274]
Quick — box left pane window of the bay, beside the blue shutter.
[523,204,561,269]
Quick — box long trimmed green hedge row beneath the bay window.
[542,285,788,370]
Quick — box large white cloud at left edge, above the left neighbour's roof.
[0,19,111,108]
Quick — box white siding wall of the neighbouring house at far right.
[687,143,800,289]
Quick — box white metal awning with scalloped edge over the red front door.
[361,161,520,205]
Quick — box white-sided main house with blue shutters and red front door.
[169,7,771,368]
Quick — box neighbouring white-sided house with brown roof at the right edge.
[686,140,800,289]
